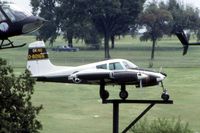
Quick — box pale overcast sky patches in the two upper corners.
[4,0,200,11]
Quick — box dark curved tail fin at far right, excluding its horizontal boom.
[173,26,189,55]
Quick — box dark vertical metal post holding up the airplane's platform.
[113,102,119,133]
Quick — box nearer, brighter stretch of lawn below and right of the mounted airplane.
[31,68,200,133]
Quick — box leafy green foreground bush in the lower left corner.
[0,58,42,133]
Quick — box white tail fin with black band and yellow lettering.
[27,41,54,77]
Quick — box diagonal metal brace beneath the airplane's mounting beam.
[122,103,155,133]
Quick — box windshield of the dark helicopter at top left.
[2,4,32,22]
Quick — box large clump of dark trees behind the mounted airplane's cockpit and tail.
[31,0,145,58]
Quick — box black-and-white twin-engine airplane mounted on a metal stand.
[27,41,169,100]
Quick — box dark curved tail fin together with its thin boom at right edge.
[172,26,200,55]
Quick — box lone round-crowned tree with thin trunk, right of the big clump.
[139,3,173,67]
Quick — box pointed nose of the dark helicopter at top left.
[22,16,46,34]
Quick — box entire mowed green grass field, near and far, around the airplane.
[0,36,200,133]
